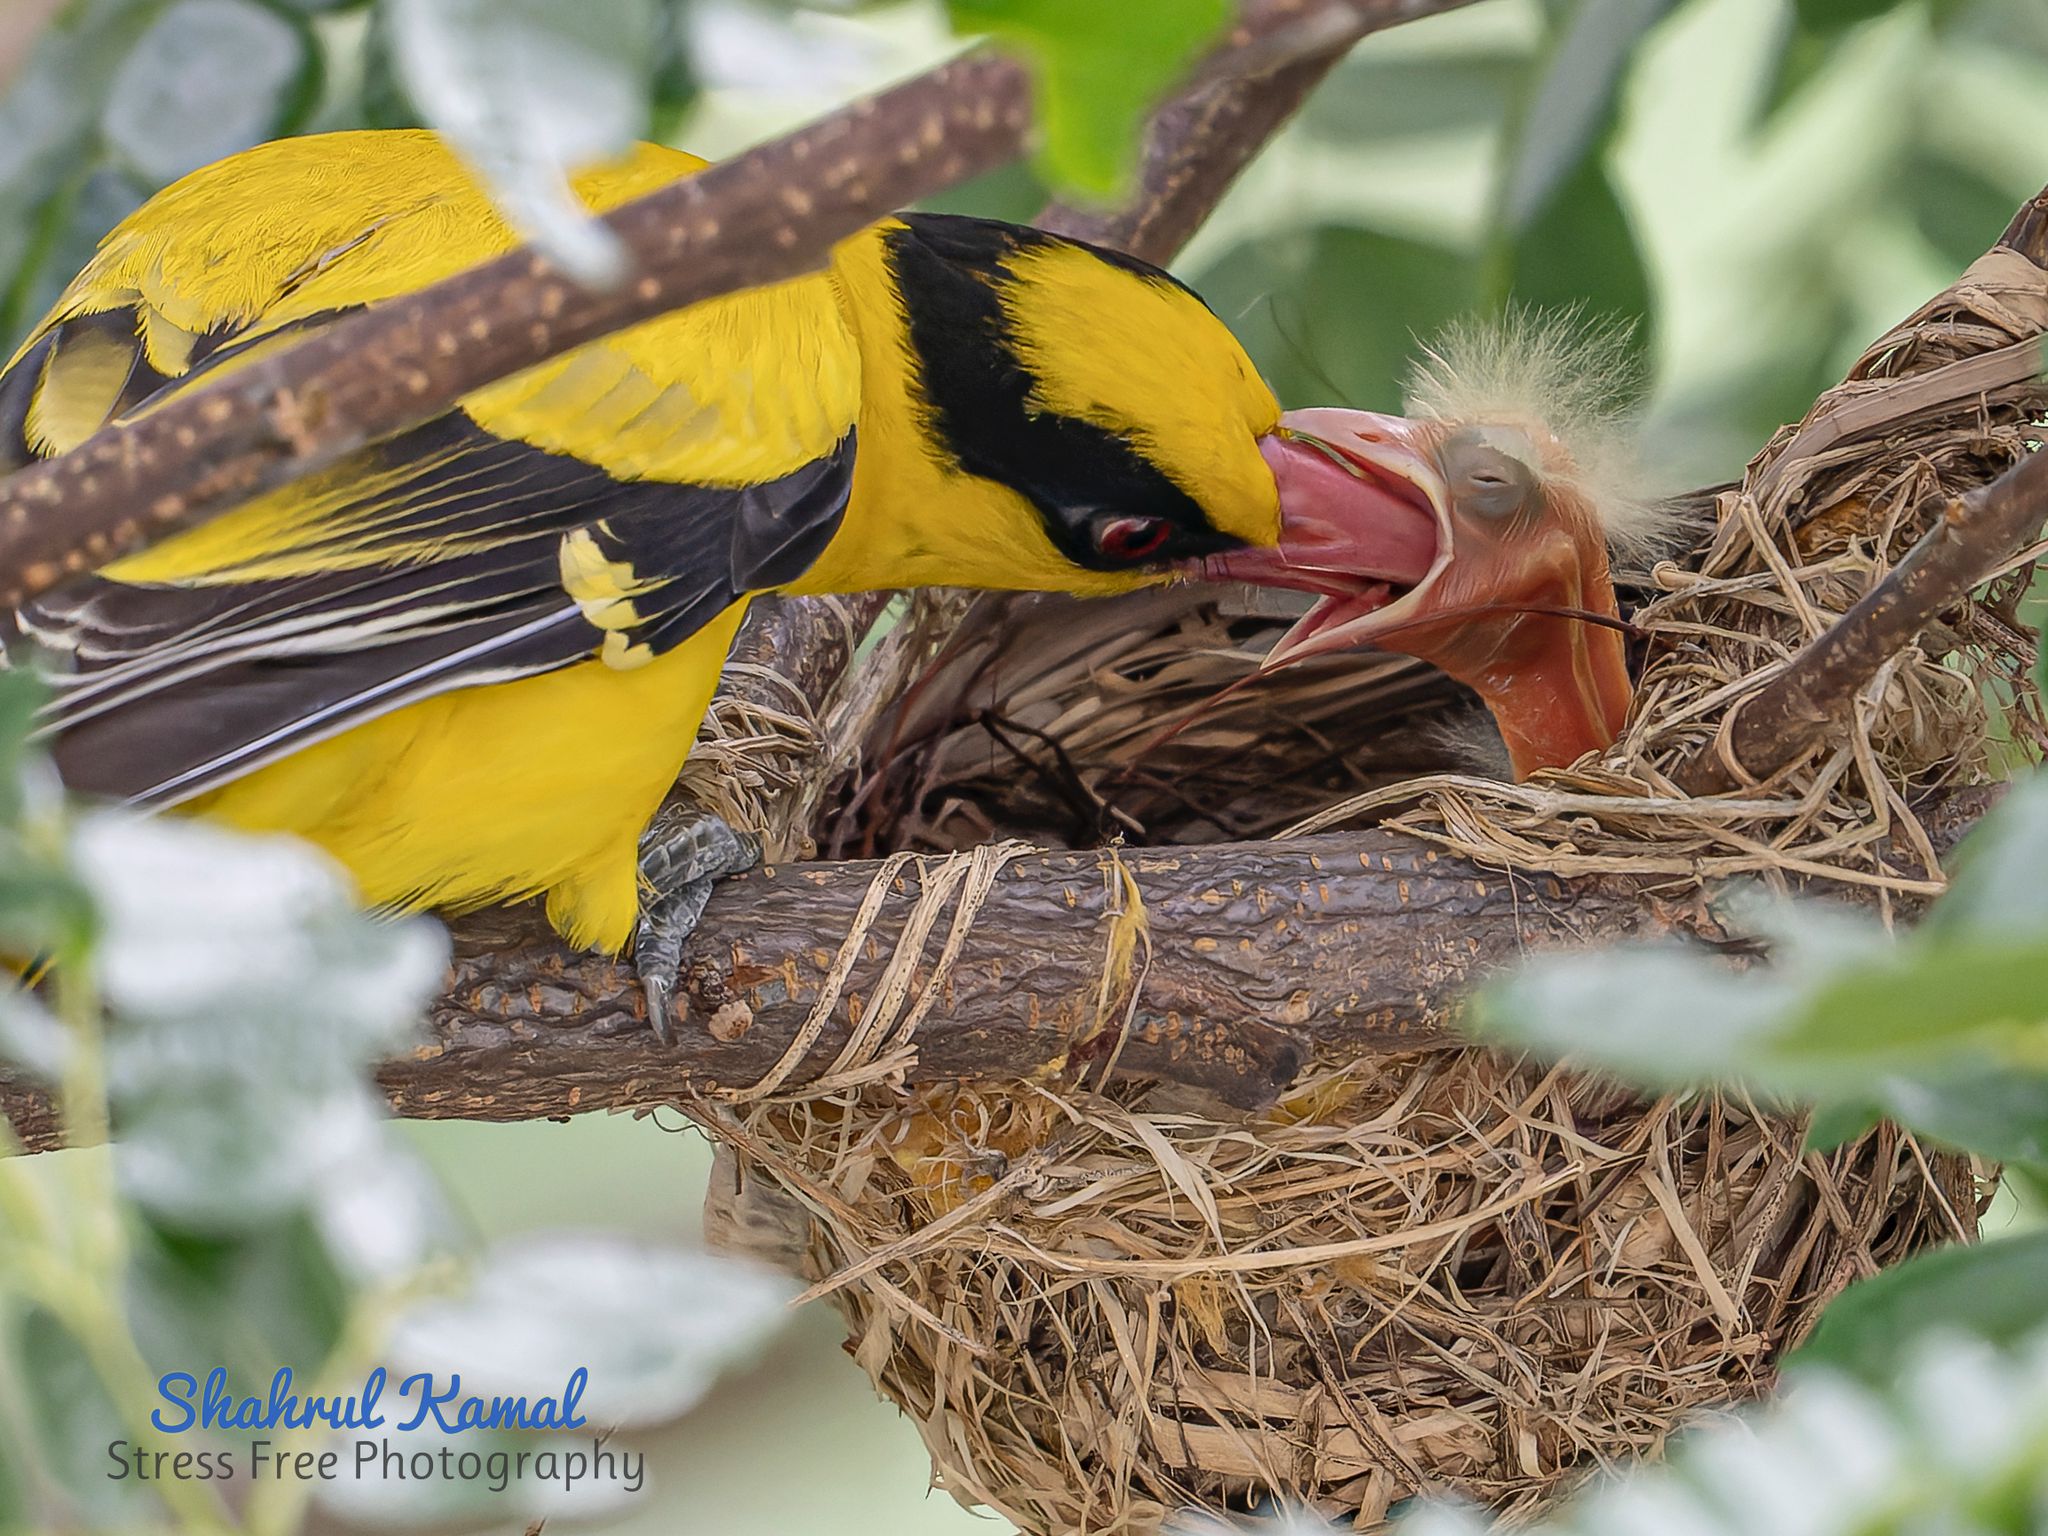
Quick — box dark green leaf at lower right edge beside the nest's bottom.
[1786,1233,2048,1386]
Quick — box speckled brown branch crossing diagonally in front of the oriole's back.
[0,0,1468,606]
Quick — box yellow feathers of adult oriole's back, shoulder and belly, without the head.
[9,135,839,950]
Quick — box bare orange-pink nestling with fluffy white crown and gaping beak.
[1200,313,1663,778]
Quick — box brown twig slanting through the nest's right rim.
[1675,453,2048,795]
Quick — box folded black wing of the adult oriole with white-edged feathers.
[16,415,854,803]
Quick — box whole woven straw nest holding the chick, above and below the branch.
[705,252,2048,1532]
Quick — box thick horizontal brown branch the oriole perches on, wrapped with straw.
[0,791,1997,1151]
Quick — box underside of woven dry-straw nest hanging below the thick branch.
[708,1053,1976,1532]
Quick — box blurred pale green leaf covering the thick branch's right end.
[1473,868,2048,1165]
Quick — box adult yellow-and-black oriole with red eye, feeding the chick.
[0,131,1626,999]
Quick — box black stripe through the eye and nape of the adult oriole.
[887,213,1239,569]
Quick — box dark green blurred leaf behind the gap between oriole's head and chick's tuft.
[1196,225,1479,412]
